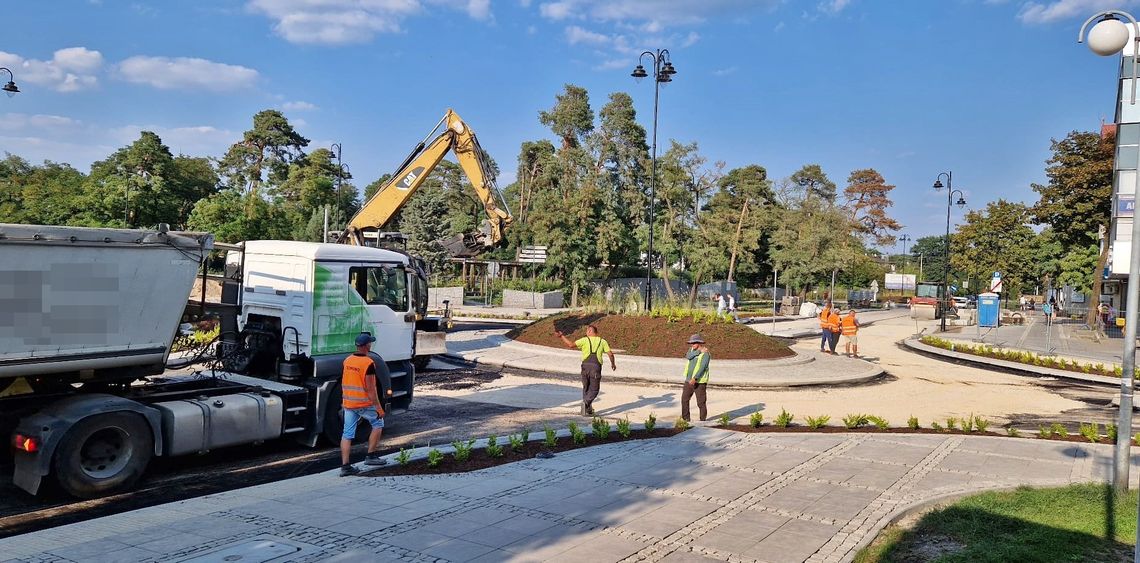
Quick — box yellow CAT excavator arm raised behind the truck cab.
[339,108,512,258]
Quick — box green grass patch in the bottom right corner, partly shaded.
[855,484,1137,563]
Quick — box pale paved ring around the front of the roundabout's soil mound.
[447,329,882,387]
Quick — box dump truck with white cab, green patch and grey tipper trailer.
[0,223,428,498]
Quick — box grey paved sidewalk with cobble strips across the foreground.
[0,429,1137,563]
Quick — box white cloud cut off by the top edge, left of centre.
[246,0,494,44]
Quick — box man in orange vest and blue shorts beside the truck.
[341,333,388,476]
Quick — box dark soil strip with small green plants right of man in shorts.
[361,429,684,478]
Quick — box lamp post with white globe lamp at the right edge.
[1076,10,1140,499]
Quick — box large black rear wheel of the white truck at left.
[52,413,154,498]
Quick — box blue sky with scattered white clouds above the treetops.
[0,0,1140,252]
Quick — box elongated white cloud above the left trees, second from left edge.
[119,56,258,92]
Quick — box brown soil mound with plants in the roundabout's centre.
[507,312,795,360]
